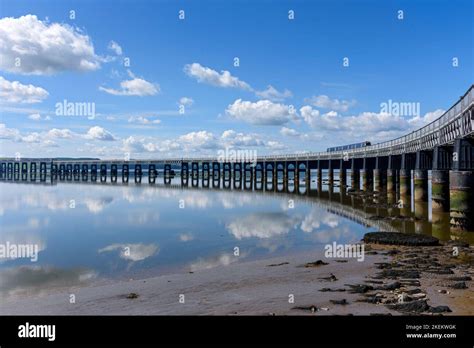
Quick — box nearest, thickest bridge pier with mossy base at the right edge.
[449,139,474,231]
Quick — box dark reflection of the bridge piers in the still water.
[0,167,474,244]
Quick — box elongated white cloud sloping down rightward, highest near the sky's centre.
[184,63,252,90]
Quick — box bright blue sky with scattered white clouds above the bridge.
[0,0,474,158]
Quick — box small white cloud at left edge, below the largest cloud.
[0,76,49,104]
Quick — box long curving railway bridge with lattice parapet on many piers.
[0,85,474,231]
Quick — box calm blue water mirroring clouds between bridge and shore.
[0,173,470,297]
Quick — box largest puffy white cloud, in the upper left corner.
[0,15,100,75]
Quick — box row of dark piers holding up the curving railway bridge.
[0,139,474,231]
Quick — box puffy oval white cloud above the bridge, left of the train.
[226,99,293,125]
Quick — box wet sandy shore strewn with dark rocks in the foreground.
[0,245,474,315]
